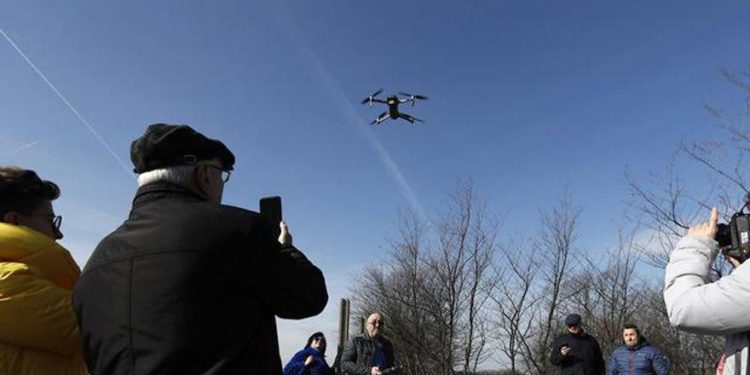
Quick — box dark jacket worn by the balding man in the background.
[341,335,395,375]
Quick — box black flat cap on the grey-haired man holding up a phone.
[130,124,234,173]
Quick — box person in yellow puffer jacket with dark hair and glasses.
[0,167,86,375]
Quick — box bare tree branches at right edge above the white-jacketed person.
[626,69,750,271]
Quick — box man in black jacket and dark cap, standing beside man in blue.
[550,314,604,375]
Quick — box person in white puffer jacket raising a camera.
[664,208,750,375]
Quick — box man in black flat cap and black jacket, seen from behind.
[73,124,328,375]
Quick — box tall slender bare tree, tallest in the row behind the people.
[428,181,497,374]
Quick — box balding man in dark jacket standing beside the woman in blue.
[341,312,396,375]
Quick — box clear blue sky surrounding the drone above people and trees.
[0,0,750,368]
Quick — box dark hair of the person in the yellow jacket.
[0,167,60,217]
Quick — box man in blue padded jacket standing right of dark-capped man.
[607,324,669,375]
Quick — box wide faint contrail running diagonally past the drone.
[267,1,430,223]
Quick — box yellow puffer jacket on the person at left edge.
[0,223,86,375]
